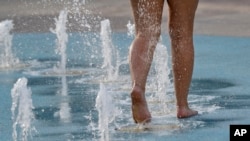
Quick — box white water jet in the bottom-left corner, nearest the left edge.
[11,78,35,141]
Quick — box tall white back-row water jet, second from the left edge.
[51,10,68,74]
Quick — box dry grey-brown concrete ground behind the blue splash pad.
[0,0,250,37]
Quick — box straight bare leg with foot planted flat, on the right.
[168,0,198,118]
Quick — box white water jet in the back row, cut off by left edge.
[0,20,19,68]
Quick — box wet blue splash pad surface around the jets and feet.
[0,33,250,141]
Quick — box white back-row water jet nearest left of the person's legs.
[101,20,120,81]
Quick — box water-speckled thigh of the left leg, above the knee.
[130,0,164,34]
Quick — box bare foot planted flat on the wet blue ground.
[177,107,198,118]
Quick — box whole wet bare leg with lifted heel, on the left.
[129,0,164,123]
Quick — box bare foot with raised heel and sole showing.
[131,87,151,123]
